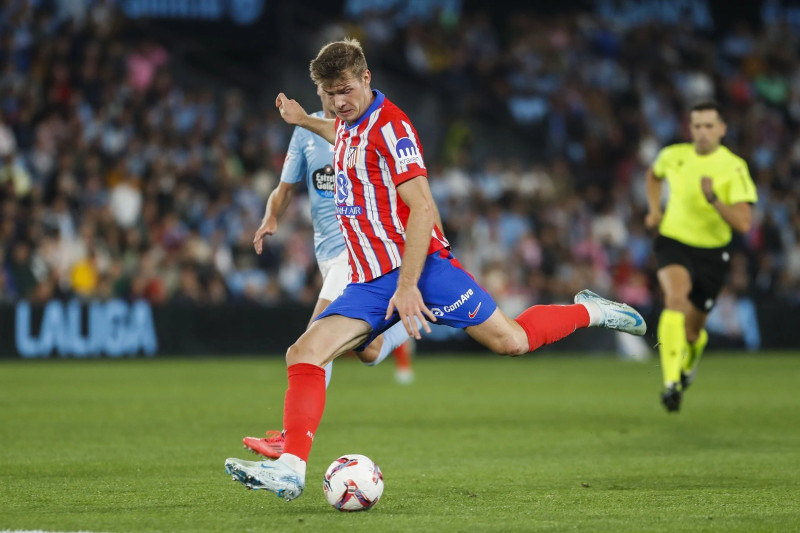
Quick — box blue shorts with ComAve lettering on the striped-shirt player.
[317,250,497,350]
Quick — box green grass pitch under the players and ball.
[0,352,800,533]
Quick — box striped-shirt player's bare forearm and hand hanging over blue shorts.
[386,177,436,339]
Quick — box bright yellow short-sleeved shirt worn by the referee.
[653,143,757,248]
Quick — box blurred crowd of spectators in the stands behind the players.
[0,0,800,344]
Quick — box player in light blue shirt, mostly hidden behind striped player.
[243,89,414,458]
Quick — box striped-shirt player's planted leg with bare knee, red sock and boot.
[225,315,371,500]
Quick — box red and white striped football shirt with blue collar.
[333,91,450,283]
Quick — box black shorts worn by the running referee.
[653,235,731,313]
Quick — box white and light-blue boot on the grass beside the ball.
[225,458,306,502]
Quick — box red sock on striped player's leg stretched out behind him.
[514,304,589,352]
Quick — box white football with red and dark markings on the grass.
[322,453,383,511]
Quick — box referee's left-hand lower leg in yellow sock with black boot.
[658,309,687,413]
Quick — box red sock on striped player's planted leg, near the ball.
[283,363,325,461]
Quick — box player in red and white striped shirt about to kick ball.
[225,39,646,500]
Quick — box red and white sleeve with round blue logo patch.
[376,117,428,186]
